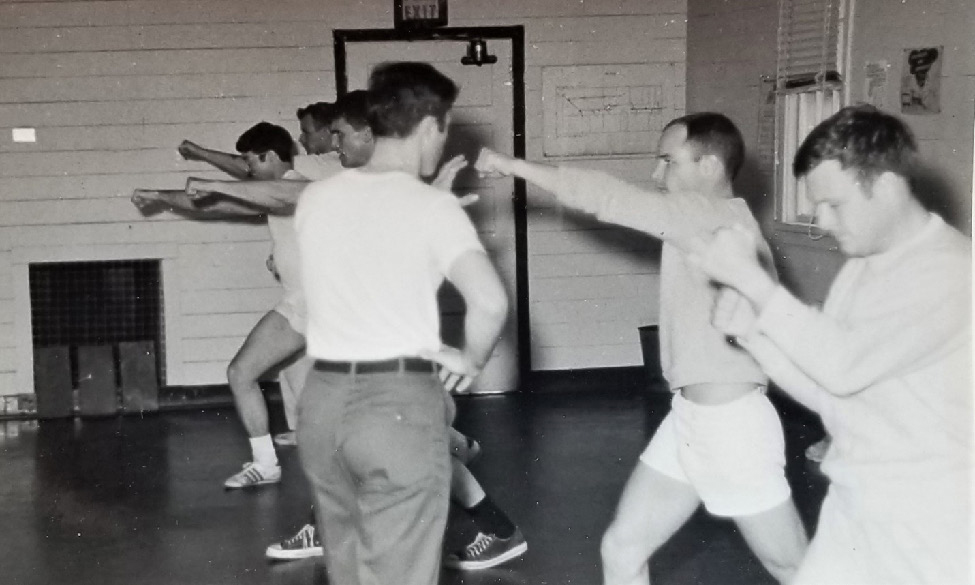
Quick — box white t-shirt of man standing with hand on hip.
[295,169,484,360]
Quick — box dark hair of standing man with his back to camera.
[368,61,459,138]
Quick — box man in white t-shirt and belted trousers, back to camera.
[295,63,508,585]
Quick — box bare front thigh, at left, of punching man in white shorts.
[600,462,701,585]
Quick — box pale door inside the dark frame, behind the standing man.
[346,40,518,393]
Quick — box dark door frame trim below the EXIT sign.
[332,26,532,389]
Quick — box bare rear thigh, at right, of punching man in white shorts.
[734,498,809,584]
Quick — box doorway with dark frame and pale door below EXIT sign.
[334,27,531,393]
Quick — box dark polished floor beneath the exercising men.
[0,384,825,585]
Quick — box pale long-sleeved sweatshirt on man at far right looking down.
[745,215,973,515]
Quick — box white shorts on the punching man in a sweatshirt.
[640,387,792,517]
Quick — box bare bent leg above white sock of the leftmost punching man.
[227,311,305,438]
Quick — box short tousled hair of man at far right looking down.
[792,104,917,185]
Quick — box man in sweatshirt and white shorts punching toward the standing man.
[476,112,806,585]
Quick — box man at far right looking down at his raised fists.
[698,106,975,585]
